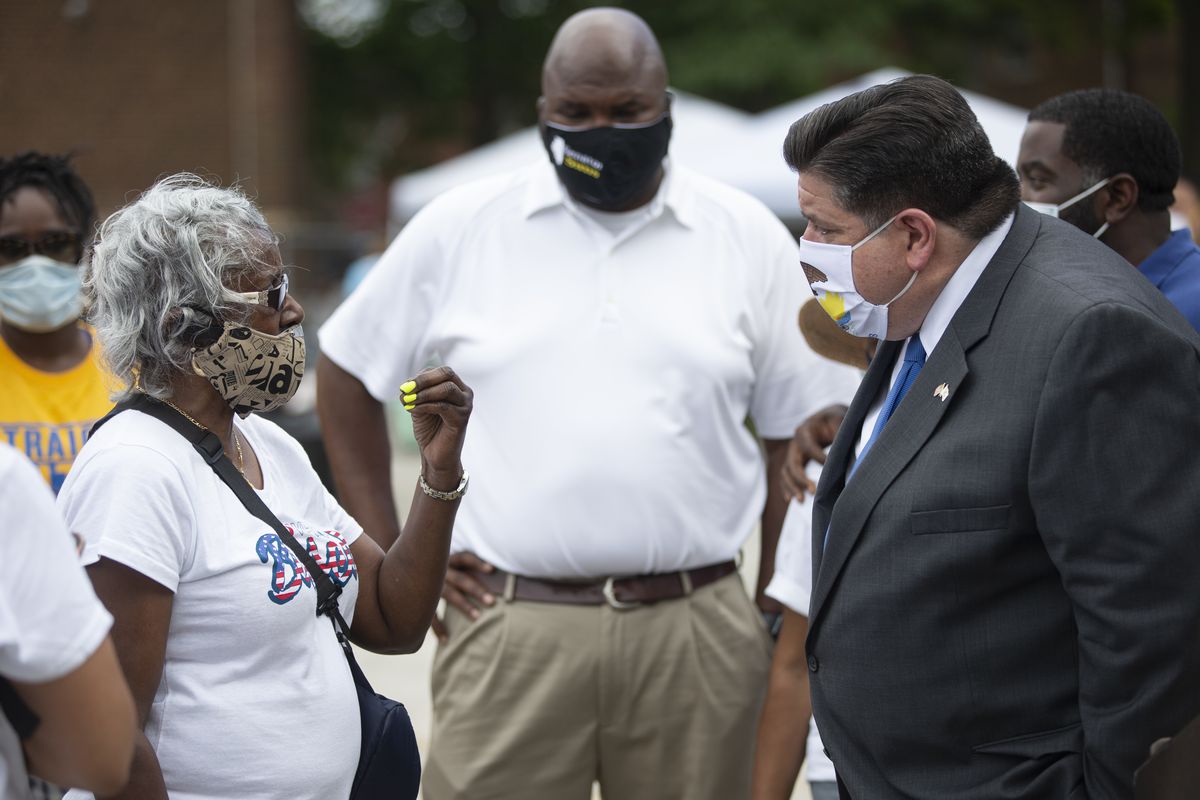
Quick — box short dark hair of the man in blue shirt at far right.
[1030,89,1183,211]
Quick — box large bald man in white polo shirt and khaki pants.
[319,8,857,800]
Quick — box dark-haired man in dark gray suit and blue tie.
[784,76,1200,800]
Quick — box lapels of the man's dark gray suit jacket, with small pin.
[809,205,1040,630]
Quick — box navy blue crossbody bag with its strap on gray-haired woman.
[91,395,421,800]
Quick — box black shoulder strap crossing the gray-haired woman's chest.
[91,392,347,618]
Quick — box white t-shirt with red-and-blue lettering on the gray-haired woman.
[59,411,362,800]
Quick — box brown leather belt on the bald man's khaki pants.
[473,561,738,609]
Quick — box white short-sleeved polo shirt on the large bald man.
[319,163,858,578]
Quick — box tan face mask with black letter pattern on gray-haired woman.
[192,323,304,419]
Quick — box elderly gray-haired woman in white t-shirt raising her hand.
[59,175,472,800]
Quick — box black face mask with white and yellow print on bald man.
[541,114,671,211]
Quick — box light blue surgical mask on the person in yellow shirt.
[0,254,83,333]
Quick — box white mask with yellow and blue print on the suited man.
[800,215,917,339]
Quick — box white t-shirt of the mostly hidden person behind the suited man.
[767,462,838,782]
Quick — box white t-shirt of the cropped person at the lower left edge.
[0,443,113,799]
